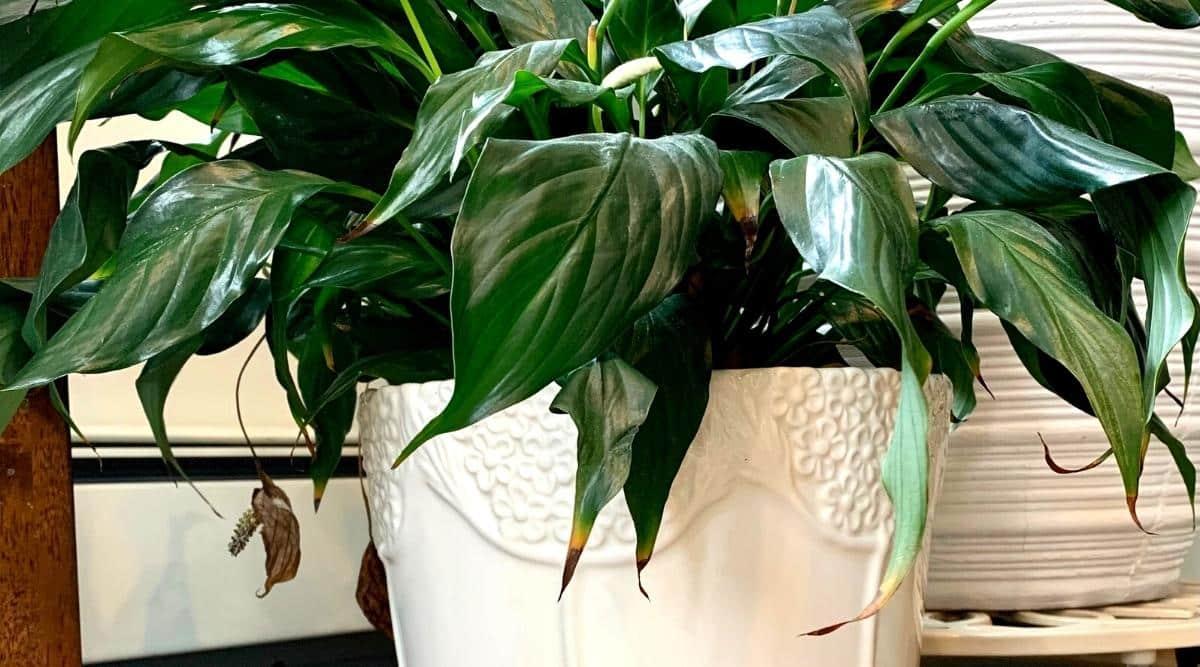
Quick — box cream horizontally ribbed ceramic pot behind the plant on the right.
[926,0,1200,609]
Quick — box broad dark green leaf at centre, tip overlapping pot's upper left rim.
[401,134,721,458]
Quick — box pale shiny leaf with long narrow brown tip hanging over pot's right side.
[770,154,926,633]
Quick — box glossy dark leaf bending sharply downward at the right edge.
[875,97,1195,436]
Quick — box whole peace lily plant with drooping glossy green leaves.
[0,0,1200,618]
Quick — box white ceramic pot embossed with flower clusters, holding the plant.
[360,368,948,667]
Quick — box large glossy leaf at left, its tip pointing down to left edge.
[12,161,332,387]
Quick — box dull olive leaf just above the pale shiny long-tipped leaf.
[716,97,854,157]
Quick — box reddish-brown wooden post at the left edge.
[0,136,82,666]
